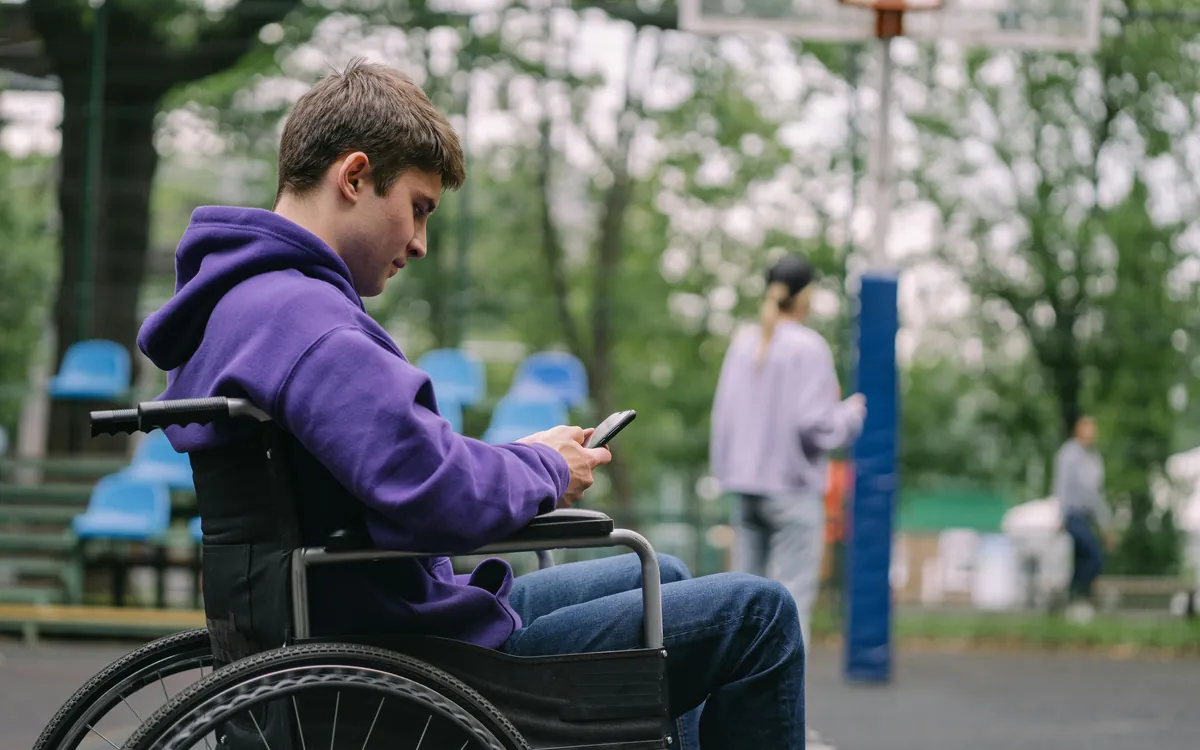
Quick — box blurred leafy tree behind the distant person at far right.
[916,4,1200,571]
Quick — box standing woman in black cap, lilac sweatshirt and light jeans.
[709,256,866,649]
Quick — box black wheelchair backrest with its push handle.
[92,398,364,666]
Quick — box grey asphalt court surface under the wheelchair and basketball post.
[7,640,1200,750]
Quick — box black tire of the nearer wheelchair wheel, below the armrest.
[122,643,530,750]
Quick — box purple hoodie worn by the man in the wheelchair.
[138,206,570,648]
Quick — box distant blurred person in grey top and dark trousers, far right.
[1054,414,1112,614]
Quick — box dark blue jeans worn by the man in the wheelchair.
[500,554,805,750]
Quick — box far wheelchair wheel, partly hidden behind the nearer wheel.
[34,628,212,750]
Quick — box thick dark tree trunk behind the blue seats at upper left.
[23,0,300,449]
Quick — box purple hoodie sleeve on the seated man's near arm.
[275,326,570,552]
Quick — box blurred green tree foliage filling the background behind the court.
[11,0,1200,570]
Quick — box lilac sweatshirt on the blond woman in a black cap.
[709,320,863,494]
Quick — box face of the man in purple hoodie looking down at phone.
[338,162,442,296]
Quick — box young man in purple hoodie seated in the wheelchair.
[139,62,804,750]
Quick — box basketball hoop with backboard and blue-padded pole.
[676,0,1103,682]
